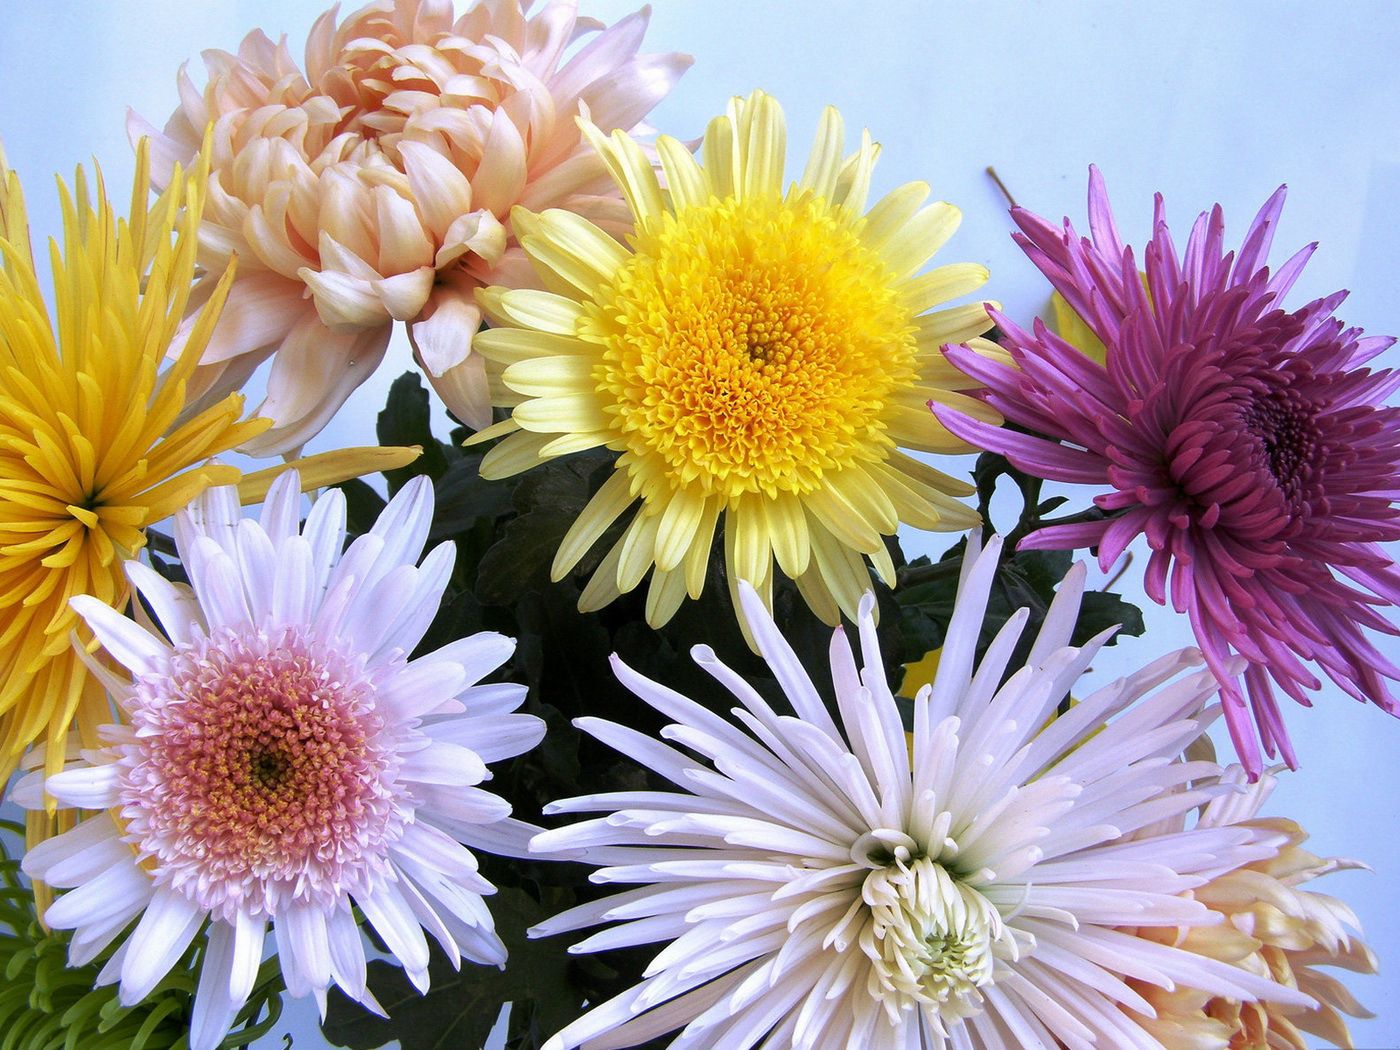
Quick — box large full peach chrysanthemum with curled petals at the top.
[129,0,690,454]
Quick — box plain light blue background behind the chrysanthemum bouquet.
[0,0,1400,1049]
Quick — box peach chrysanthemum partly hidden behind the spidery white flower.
[1131,766,1376,1050]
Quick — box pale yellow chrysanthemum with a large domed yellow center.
[476,92,1000,626]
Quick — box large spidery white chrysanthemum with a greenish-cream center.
[531,535,1312,1050]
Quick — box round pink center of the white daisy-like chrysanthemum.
[122,629,400,913]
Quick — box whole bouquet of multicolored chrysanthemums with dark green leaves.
[0,0,1400,1050]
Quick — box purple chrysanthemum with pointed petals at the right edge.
[932,168,1400,776]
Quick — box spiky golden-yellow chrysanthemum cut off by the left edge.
[0,146,267,783]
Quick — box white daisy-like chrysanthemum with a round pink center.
[14,472,545,1050]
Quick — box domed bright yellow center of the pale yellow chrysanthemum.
[582,195,917,498]
